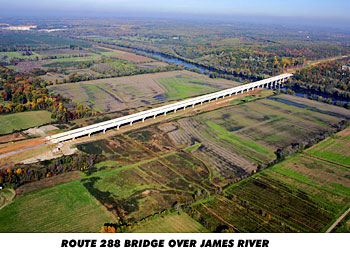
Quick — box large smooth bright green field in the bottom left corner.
[0,181,114,232]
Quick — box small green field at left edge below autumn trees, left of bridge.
[0,111,52,134]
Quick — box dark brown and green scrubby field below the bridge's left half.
[78,128,215,221]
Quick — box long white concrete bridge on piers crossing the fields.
[46,74,293,143]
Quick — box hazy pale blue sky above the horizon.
[0,0,350,30]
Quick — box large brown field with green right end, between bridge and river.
[49,71,238,112]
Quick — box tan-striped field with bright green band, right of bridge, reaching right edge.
[165,95,350,184]
